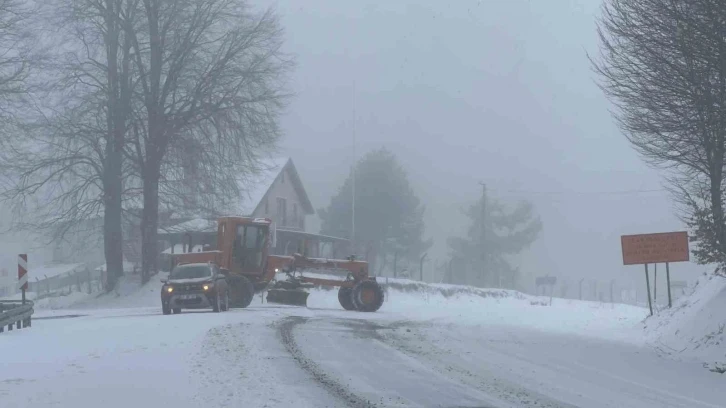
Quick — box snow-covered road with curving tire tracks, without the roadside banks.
[0,305,726,408]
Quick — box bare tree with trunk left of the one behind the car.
[0,0,137,290]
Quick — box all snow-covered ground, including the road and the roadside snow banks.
[0,278,726,408]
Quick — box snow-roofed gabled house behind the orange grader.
[158,157,348,267]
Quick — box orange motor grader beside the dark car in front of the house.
[172,217,384,312]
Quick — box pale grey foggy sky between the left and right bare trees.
[258,0,706,294]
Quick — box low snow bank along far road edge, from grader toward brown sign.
[308,279,647,343]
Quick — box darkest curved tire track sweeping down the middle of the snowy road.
[279,316,378,408]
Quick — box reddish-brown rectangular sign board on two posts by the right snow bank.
[620,231,690,265]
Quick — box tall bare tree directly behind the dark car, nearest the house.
[129,0,291,280]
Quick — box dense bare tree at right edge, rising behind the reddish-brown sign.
[593,0,726,270]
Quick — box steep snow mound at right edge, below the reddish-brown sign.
[645,275,726,370]
